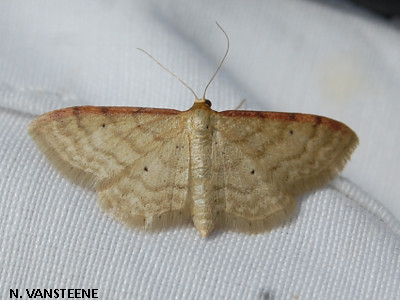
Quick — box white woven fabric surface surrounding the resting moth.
[0,0,400,299]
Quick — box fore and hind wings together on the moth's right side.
[214,111,358,232]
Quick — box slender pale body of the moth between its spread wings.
[187,102,217,236]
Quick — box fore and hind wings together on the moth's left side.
[29,106,189,228]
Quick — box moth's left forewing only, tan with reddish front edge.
[28,106,185,185]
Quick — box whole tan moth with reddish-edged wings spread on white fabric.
[29,99,358,236]
